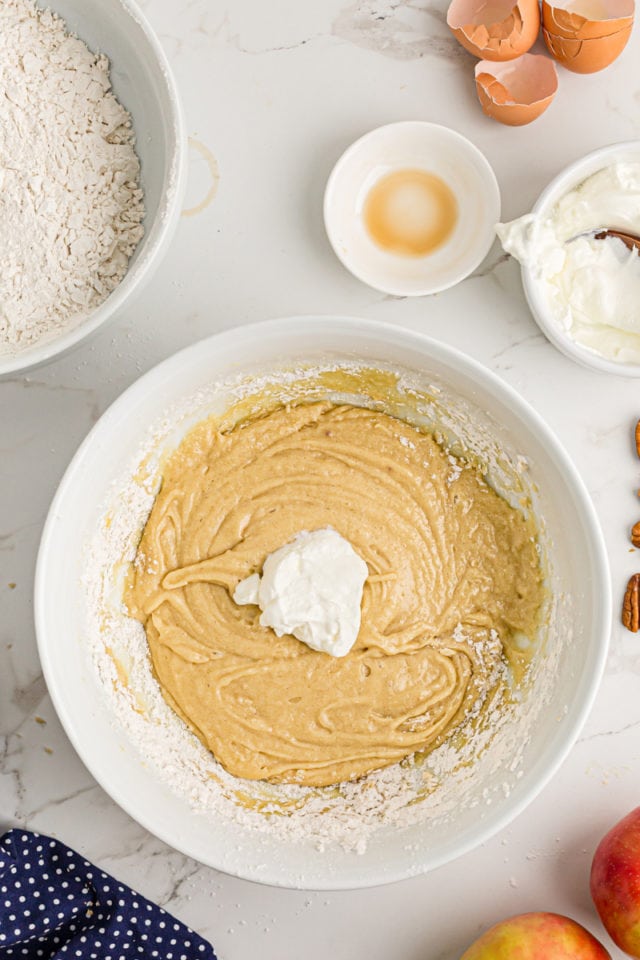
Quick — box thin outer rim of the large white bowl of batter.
[34,315,612,890]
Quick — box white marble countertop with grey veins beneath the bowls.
[0,0,640,960]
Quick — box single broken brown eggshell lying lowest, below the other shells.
[475,53,558,127]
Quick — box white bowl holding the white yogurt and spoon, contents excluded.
[521,140,640,377]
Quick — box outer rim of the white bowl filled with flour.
[0,0,187,380]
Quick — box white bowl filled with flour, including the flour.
[0,0,186,376]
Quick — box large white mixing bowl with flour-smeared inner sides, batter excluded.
[35,317,611,889]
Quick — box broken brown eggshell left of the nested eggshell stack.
[447,0,540,61]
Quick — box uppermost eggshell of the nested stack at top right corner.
[542,0,634,40]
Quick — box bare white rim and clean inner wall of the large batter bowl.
[35,318,611,889]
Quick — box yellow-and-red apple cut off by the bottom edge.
[460,913,611,960]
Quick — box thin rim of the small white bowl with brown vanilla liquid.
[322,120,502,297]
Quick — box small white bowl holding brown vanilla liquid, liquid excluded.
[324,120,500,297]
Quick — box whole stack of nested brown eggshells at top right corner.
[542,0,634,73]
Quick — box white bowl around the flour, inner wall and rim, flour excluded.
[0,0,186,378]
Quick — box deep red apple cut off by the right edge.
[591,807,640,957]
